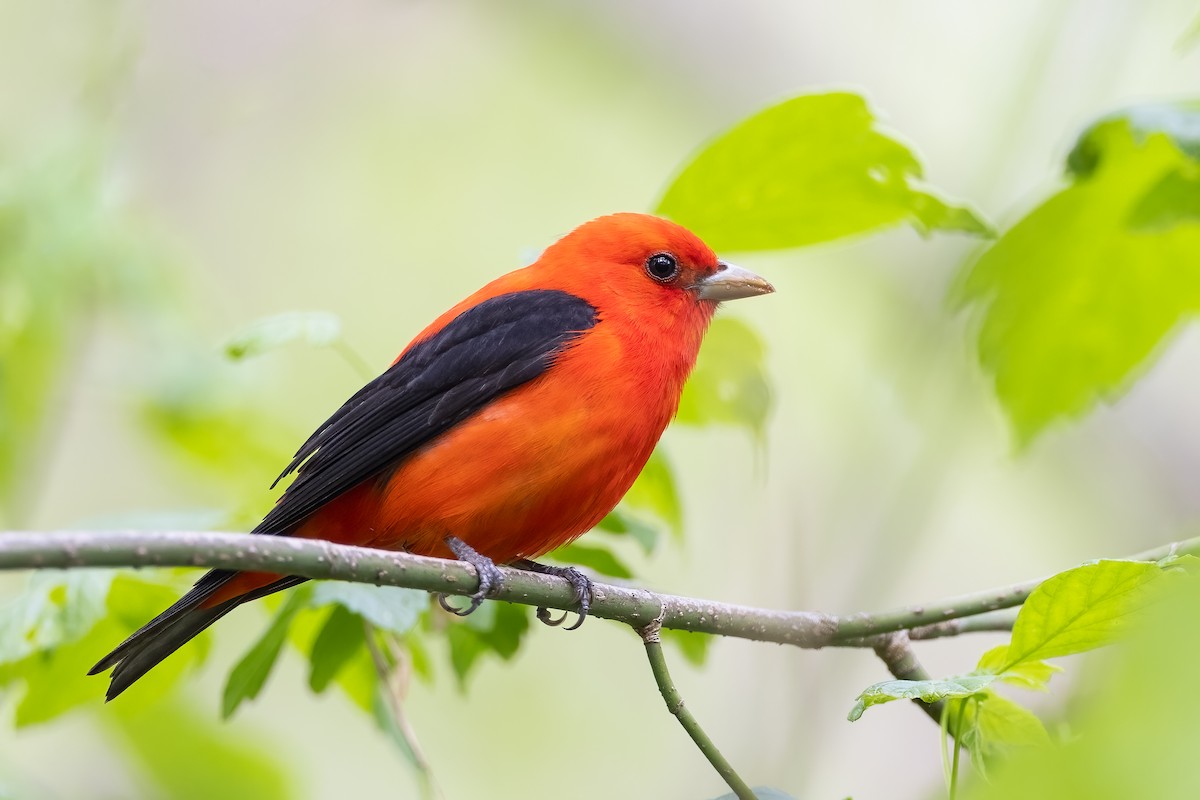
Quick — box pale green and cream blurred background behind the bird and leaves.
[0,0,1200,799]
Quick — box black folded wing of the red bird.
[253,289,598,534]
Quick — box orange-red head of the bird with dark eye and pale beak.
[541,213,775,315]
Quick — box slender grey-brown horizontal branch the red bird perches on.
[0,531,1200,649]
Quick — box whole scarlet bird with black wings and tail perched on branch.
[90,213,773,699]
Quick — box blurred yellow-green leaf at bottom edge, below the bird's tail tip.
[112,697,294,800]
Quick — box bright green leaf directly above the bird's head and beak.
[658,92,990,251]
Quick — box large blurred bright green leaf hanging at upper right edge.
[958,121,1200,445]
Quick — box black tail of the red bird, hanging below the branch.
[88,570,307,700]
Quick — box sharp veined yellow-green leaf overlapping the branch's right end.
[998,561,1163,673]
